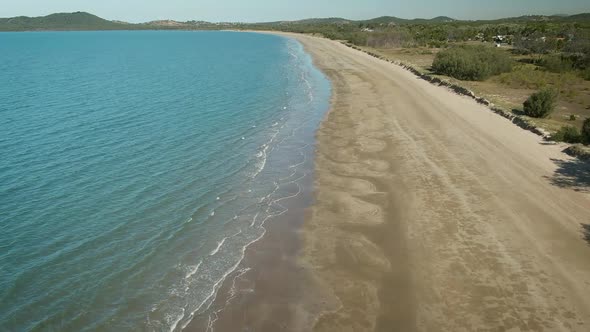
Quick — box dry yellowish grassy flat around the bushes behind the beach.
[362,42,590,133]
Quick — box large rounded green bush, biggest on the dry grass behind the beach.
[432,46,512,81]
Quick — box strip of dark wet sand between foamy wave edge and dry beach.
[181,33,328,332]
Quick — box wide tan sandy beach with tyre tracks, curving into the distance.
[286,35,590,331]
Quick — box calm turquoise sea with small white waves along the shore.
[0,31,330,331]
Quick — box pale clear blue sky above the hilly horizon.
[0,0,590,22]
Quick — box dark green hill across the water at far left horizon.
[0,12,129,31]
